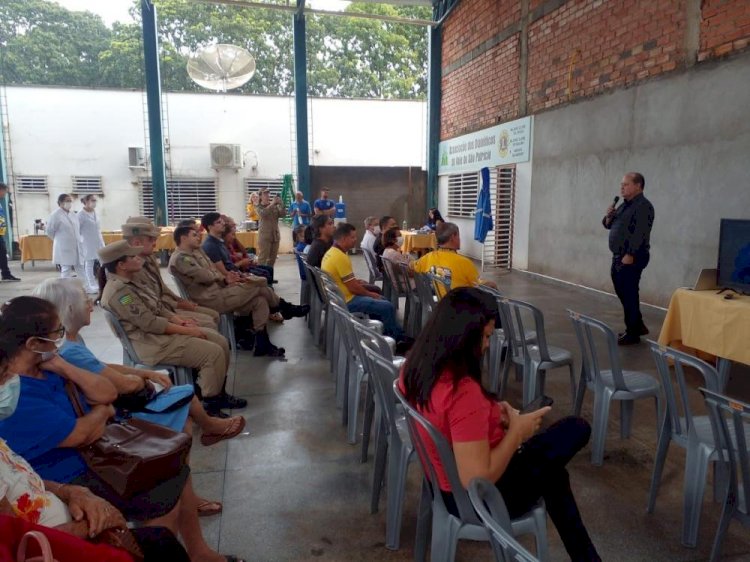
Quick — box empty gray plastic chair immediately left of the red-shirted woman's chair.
[361,338,414,550]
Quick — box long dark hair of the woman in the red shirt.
[404,287,497,407]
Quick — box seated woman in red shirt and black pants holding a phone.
[400,287,600,561]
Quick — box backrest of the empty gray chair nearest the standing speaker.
[568,309,629,391]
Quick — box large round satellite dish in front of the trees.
[187,43,255,92]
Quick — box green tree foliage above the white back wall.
[0,0,429,99]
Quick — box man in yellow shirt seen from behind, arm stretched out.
[414,222,497,289]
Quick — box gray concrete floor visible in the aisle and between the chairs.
[0,256,750,561]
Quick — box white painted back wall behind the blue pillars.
[7,86,426,234]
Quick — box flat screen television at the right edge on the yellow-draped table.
[716,219,750,294]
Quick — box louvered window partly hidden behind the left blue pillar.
[141,178,217,224]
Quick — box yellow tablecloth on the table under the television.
[659,289,750,365]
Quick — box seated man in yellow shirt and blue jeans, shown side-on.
[320,223,405,342]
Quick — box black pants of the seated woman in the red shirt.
[443,416,600,562]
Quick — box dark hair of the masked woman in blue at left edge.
[0,296,59,358]
